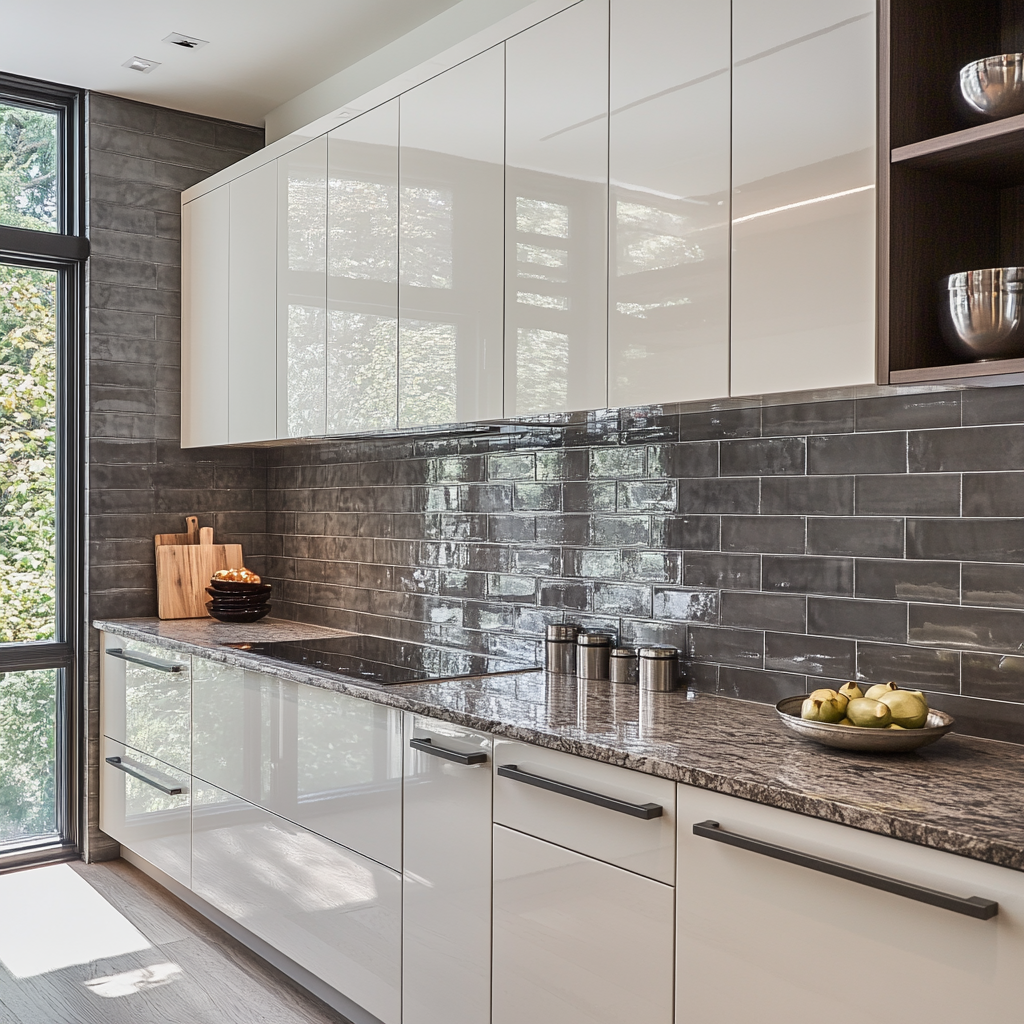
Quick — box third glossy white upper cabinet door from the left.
[278,136,327,437]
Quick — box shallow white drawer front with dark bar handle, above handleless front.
[495,738,676,885]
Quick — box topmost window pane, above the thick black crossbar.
[0,103,60,231]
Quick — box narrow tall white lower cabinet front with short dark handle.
[402,713,490,1024]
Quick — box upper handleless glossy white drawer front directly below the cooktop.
[193,658,401,870]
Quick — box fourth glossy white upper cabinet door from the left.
[327,99,398,434]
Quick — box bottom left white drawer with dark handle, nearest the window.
[99,736,191,886]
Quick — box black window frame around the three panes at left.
[0,73,89,871]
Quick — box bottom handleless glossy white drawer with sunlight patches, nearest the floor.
[193,782,401,1024]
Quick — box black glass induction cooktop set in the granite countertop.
[224,634,537,685]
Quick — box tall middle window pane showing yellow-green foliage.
[0,264,57,643]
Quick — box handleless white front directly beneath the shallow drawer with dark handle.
[490,825,675,1024]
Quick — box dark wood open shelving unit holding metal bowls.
[879,0,1024,384]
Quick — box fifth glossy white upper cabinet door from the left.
[398,46,505,427]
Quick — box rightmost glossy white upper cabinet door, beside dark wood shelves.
[732,0,877,394]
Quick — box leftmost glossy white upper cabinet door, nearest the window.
[181,186,230,447]
